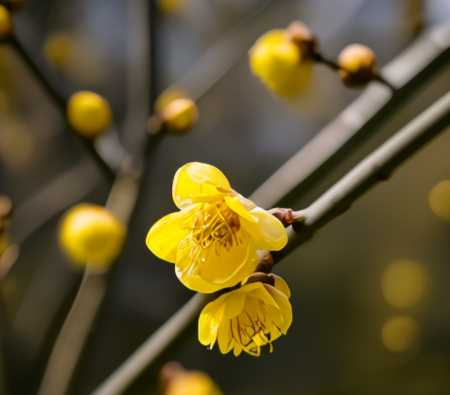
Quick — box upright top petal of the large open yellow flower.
[172,162,231,208]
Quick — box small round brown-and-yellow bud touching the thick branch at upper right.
[337,44,376,86]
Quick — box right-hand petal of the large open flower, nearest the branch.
[241,207,288,251]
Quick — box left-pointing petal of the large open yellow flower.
[146,205,197,263]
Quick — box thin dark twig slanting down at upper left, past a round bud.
[7,35,119,180]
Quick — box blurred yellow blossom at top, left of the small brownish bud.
[249,29,312,98]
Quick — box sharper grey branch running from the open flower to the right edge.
[273,92,450,262]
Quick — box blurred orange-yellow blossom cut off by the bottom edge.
[164,371,222,395]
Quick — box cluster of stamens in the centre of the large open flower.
[192,202,240,252]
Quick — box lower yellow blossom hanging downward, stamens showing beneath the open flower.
[198,275,292,356]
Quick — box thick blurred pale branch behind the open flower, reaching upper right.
[253,25,450,207]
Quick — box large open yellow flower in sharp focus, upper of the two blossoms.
[147,162,287,293]
